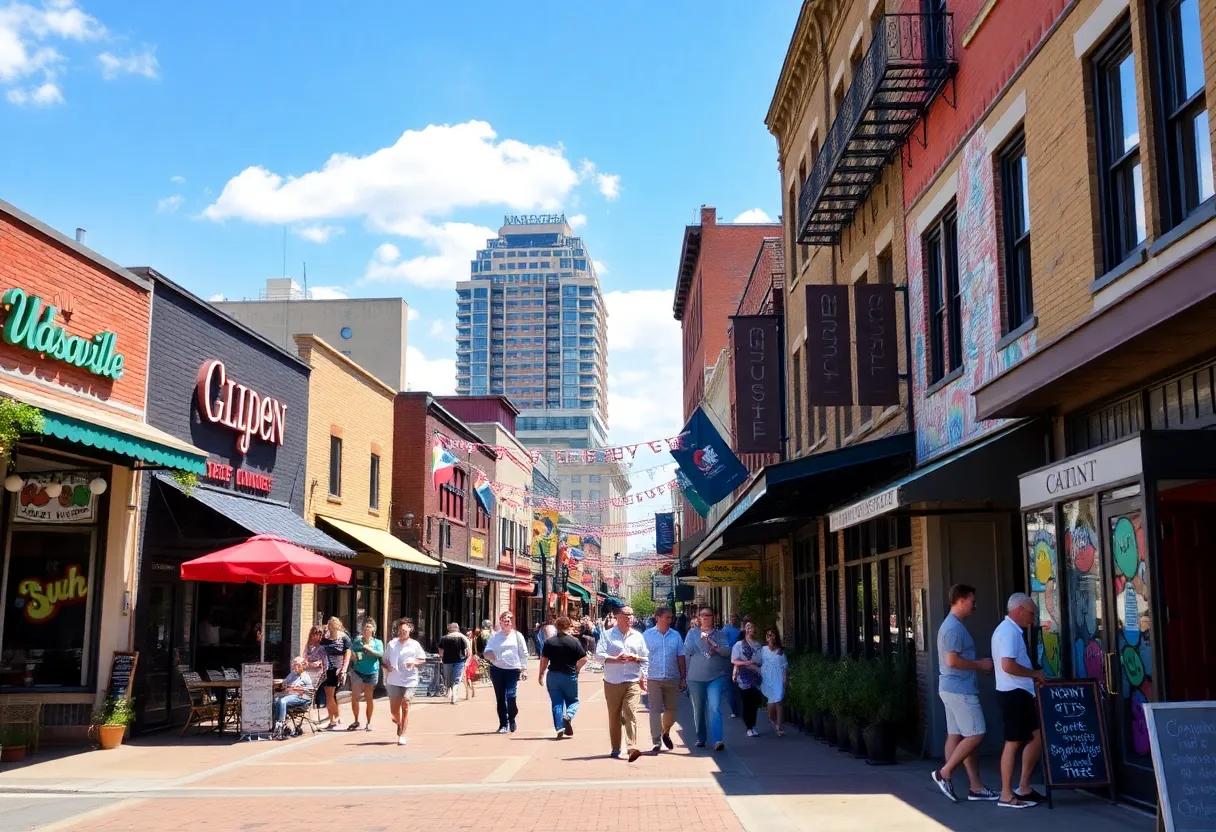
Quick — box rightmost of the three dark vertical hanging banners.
[852,283,900,407]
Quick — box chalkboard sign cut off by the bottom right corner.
[1144,702,1216,832]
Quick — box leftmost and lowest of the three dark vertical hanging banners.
[731,315,786,454]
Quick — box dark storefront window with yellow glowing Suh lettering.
[0,527,96,687]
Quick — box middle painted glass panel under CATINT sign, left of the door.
[1062,496,1107,679]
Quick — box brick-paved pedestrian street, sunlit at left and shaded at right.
[0,663,1153,832]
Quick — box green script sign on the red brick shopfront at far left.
[0,288,125,381]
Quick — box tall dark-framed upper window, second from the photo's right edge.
[1093,23,1147,271]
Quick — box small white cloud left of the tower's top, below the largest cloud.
[361,220,496,288]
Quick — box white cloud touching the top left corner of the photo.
[0,0,107,107]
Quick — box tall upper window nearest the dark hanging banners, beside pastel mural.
[924,204,963,383]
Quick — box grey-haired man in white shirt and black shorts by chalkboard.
[992,592,1046,809]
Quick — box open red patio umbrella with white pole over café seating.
[181,534,350,662]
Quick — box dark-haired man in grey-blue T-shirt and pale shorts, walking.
[933,584,1001,803]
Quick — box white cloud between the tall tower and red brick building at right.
[604,289,683,443]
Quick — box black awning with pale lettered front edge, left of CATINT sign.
[828,421,1047,532]
